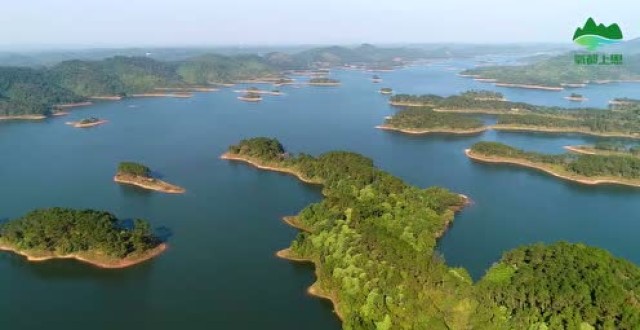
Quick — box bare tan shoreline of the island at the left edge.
[0,242,168,269]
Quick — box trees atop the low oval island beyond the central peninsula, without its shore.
[385,107,484,130]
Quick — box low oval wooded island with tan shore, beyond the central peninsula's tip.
[377,107,488,134]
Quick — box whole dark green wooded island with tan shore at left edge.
[0,208,167,268]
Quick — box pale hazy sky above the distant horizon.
[0,0,640,47]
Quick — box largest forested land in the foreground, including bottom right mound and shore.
[223,138,640,330]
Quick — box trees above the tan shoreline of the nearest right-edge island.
[471,142,640,179]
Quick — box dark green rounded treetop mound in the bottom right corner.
[477,242,640,329]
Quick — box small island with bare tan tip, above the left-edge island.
[113,162,185,194]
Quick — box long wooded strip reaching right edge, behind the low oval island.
[391,91,640,138]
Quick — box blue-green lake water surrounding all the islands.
[0,60,640,330]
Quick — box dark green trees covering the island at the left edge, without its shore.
[0,208,160,258]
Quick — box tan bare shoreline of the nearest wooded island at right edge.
[464,149,640,187]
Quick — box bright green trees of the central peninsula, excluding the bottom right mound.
[230,138,470,329]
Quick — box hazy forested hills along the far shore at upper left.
[0,55,277,116]
